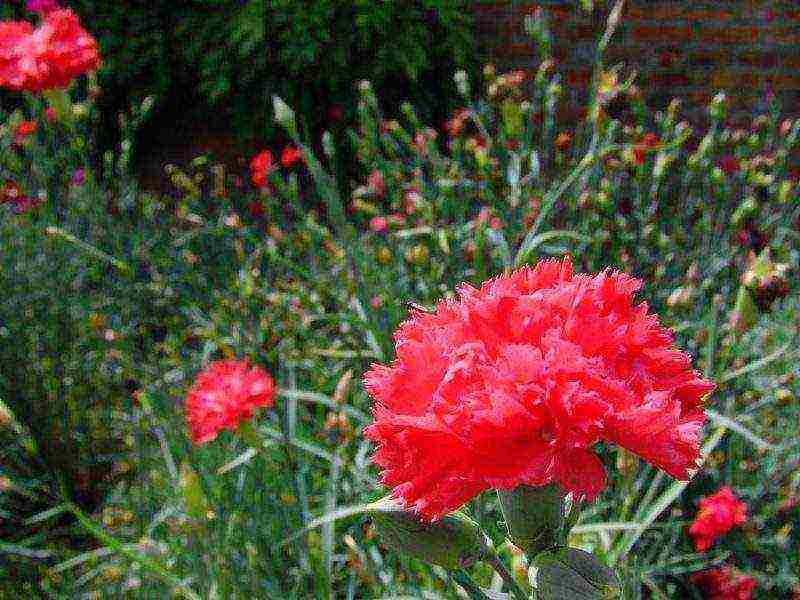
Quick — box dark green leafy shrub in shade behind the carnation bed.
[74,0,472,136]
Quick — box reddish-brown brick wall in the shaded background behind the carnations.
[473,0,800,124]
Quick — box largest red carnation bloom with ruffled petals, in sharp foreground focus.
[365,258,714,520]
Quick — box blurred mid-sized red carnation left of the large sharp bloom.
[186,360,275,444]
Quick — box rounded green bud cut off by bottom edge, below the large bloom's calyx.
[534,548,622,600]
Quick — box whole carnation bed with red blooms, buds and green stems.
[0,0,800,600]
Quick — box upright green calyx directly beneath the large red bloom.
[497,485,566,557]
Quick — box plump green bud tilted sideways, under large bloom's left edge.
[372,499,487,569]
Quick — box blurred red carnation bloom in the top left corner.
[0,9,100,92]
